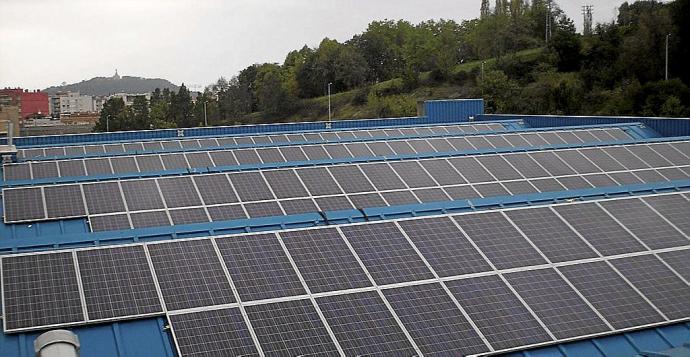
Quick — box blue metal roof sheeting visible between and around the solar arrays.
[0,103,690,357]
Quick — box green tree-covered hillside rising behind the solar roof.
[92,0,690,130]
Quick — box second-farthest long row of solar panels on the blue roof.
[3,128,628,181]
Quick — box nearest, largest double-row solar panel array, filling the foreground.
[1,193,690,355]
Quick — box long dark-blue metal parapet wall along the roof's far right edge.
[475,114,690,136]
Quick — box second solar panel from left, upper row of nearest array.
[77,246,163,319]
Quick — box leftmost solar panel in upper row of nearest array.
[2,253,85,332]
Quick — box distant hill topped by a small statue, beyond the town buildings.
[45,76,178,95]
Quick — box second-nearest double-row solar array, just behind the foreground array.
[3,141,690,228]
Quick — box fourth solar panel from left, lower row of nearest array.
[384,284,489,356]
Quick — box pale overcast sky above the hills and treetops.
[0,0,622,89]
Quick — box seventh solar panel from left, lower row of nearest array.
[558,262,663,329]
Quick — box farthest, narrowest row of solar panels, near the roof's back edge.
[17,123,506,160]
